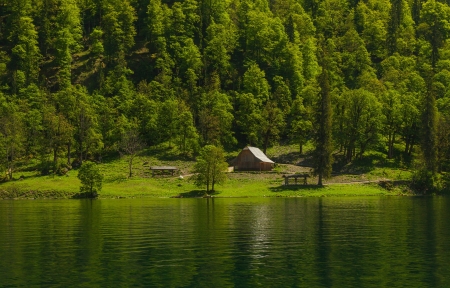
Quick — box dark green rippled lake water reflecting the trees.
[0,197,450,287]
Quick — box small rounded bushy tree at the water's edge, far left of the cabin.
[78,162,103,198]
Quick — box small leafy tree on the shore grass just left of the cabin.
[192,145,228,194]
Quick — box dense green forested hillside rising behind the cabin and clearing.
[0,0,450,182]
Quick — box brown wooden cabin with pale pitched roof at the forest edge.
[233,146,275,171]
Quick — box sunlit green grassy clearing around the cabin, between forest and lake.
[0,146,411,199]
